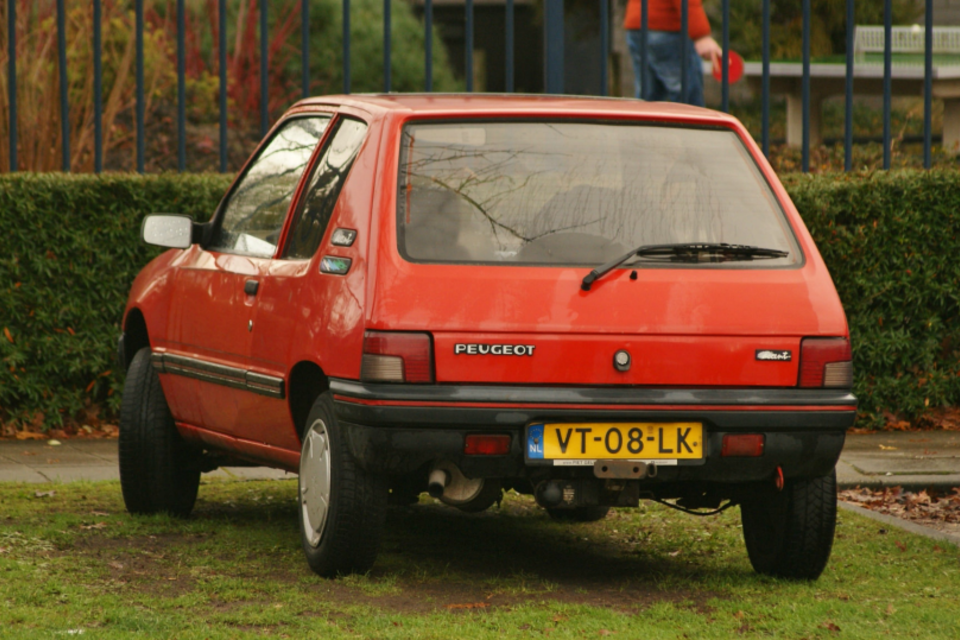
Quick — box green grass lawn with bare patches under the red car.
[0,480,960,640]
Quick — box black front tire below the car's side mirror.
[119,347,201,517]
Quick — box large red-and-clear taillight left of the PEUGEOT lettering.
[360,331,433,382]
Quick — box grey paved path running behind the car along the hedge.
[0,431,960,489]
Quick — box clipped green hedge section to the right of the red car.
[784,170,960,426]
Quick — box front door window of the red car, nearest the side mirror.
[210,116,330,258]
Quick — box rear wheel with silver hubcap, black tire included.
[297,393,388,578]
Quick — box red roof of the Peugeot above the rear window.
[297,93,736,122]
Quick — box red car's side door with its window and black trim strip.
[163,114,330,434]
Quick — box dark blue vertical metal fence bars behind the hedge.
[0,0,934,172]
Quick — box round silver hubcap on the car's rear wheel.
[300,420,330,547]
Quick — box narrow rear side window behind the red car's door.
[284,118,367,258]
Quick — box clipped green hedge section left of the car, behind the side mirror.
[0,174,230,425]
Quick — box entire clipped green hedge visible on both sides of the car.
[0,171,960,426]
